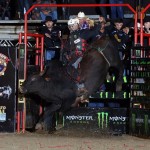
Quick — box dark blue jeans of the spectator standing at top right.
[109,0,124,19]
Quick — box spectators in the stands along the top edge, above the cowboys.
[0,0,149,20]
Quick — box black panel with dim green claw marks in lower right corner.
[130,109,150,137]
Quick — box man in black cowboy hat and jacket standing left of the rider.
[40,16,61,65]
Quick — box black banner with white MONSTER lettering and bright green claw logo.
[64,108,128,133]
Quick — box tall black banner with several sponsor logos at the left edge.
[0,47,17,132]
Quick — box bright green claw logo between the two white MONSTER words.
[97,112,108,129]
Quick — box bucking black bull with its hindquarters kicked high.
[20,38,123,130]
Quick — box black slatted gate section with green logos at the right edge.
[130,46,150,106]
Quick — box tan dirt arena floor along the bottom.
[0,129,150,150]
